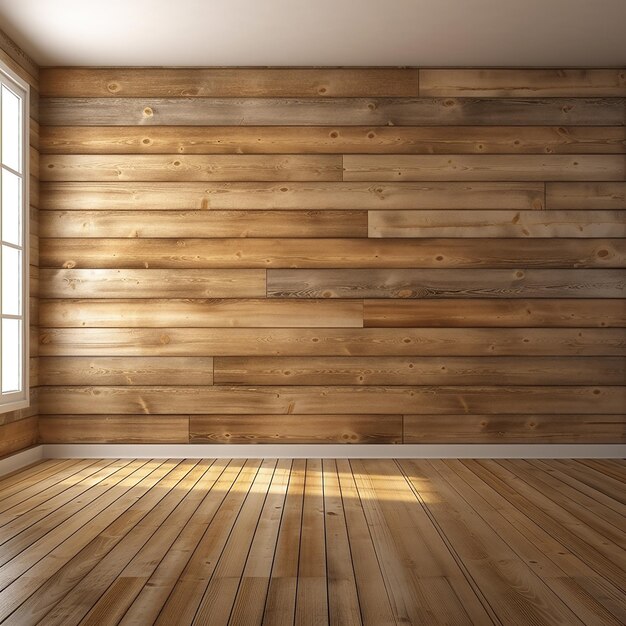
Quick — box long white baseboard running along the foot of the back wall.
[43,443,626,459]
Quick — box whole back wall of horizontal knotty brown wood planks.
[39,68,626,443]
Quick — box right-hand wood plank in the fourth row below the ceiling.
[342,154,626,181]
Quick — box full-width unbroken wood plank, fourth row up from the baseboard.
[39,328,626,356]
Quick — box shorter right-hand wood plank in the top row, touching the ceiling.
[419,68,626,98]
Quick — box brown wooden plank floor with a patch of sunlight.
[0,459,626,626]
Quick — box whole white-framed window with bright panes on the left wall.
[0,65,29,412]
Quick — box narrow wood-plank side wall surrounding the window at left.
[0,30,39,457]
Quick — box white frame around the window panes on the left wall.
[0,61,30,414]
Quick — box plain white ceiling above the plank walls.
[0,0,626,67]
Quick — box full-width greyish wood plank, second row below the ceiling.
[40,97,626,126]
